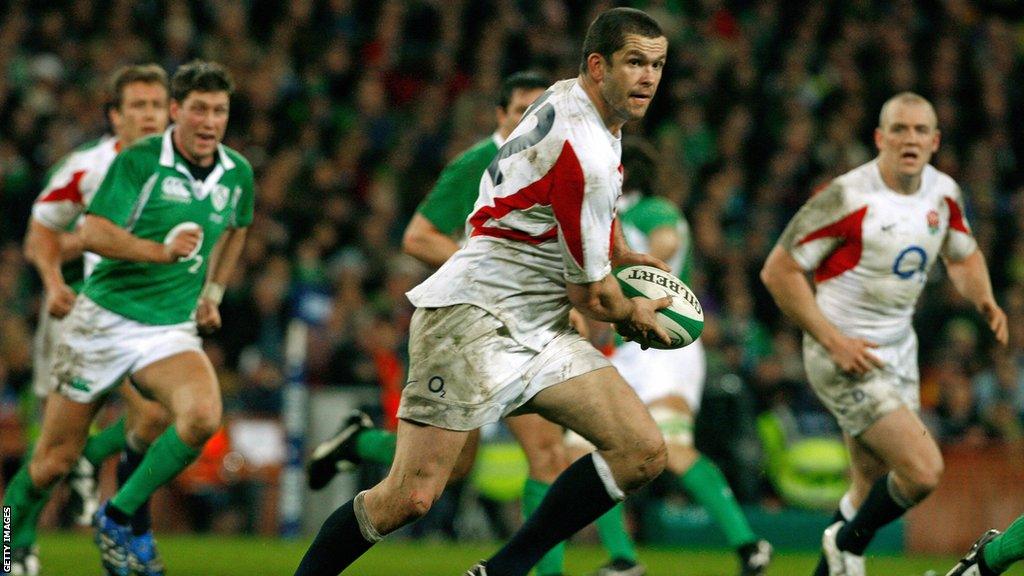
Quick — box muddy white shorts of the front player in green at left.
[53,295,203,403]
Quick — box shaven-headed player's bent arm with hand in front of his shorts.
[761,246,883,374]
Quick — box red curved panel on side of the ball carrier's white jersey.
[469,141,583,255]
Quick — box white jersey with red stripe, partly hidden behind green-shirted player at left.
[32,135,121,232]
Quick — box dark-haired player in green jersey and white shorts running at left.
[8,61,254,576]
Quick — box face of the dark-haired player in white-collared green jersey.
[171,90,230,166]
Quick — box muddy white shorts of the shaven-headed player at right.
[804,330,921,436]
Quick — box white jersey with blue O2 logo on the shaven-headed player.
[779,160,977,344]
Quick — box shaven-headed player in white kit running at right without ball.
[761,92,1008,576]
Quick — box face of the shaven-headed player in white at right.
[874,101,939,177]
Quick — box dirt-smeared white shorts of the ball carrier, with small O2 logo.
[398,304,610,430]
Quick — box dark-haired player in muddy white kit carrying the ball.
[296,8,671,576]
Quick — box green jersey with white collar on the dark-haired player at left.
[84,126,255,325]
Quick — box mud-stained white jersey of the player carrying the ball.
[408,79,623,351]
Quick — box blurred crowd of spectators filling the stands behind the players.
[0,0,1024,528]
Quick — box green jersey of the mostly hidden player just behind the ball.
[618,196,693,284]
